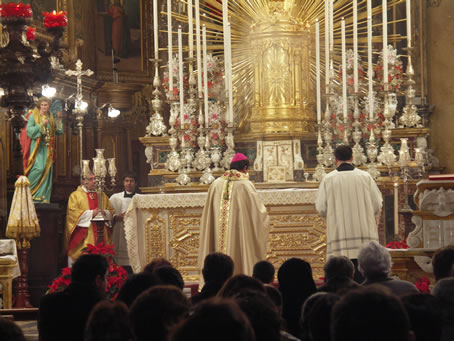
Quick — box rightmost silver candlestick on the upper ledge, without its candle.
[399,48,422,128]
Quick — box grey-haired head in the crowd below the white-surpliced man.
[358,241,392,278]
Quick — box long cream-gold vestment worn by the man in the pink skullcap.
[198,170,270,276]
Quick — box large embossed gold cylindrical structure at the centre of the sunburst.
[245,9,314,134]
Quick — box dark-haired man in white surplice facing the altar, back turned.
[315,145,383,263]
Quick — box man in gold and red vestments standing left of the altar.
[66,174,114,262]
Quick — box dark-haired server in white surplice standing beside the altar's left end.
[110,172,136,270]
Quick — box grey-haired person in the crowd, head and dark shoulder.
[358,241,419,296]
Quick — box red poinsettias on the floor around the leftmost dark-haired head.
[46,243,126,299]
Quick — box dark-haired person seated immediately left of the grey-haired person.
[318,256,359,293]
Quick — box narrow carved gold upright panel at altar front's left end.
[145,209,167,260]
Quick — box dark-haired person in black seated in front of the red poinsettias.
[38,254,109,341]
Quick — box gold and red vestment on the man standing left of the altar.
[66,186,114,260]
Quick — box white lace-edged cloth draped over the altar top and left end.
[124,189,317,272]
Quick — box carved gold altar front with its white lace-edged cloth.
[125,189,326,282]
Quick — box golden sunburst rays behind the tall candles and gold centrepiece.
[161,0,406,123]
